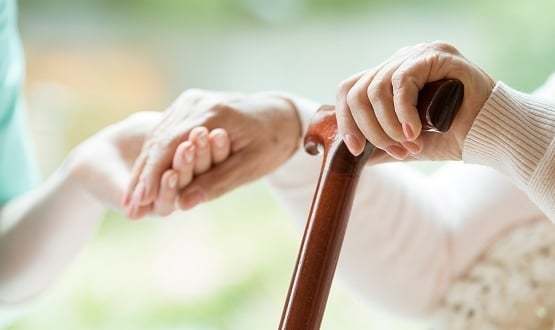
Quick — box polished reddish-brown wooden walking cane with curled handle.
[279,79,464,330]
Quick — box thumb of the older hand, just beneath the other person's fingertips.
[177,152,253,210]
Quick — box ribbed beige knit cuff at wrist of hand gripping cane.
[463,82,555,187]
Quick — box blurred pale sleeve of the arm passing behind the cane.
[269,101,542,315]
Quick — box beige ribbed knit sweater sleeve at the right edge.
[463,82,555,221]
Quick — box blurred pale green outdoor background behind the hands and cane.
[4,0,555,330]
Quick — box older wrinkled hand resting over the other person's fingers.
[124,89,301,213]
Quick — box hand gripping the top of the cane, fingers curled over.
[336,42,495,160]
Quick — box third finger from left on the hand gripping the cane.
[368,60,406,142]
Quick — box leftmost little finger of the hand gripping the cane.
[335,73,366,156]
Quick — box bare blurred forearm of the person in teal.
[0,159,103,304]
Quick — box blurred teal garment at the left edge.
[0,0,38,205]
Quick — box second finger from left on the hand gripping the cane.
[347,73,408,160]
